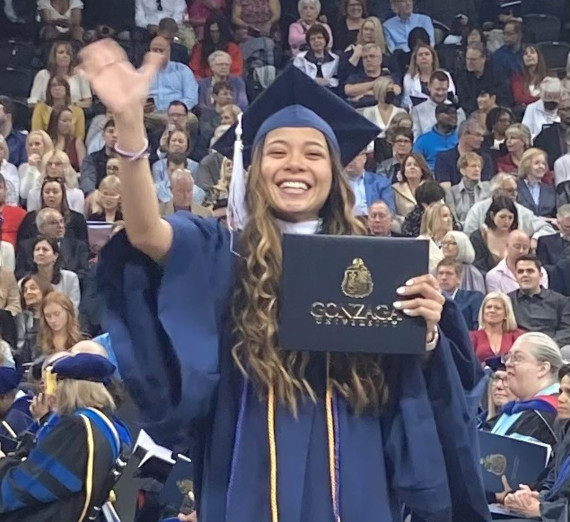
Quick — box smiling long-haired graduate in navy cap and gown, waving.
[77,42,488,522]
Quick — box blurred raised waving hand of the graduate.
[77,39,164,116]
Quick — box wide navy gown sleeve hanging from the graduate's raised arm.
[98,212,232,449]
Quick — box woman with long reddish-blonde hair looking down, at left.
[37,292,83,355]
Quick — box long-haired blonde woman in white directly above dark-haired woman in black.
[27,150,85,213]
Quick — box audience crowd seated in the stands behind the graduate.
[0,0,570,520]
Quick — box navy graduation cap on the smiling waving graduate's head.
[214,65,380,168]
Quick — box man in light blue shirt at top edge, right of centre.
[384,0,435,53]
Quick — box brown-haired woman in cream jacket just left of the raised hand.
[28,42,93,109]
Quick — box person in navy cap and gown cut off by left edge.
[0,366,33,446]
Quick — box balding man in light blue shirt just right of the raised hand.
[144,36,198,126]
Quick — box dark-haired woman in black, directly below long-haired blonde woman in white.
[18,177,88,243]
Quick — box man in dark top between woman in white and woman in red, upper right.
[455,43,510,114]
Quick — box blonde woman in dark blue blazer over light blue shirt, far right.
[517,148,556,219]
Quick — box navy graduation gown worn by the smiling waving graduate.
[99,213,489,522]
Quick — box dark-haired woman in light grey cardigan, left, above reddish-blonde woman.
[26,236,81,310]
